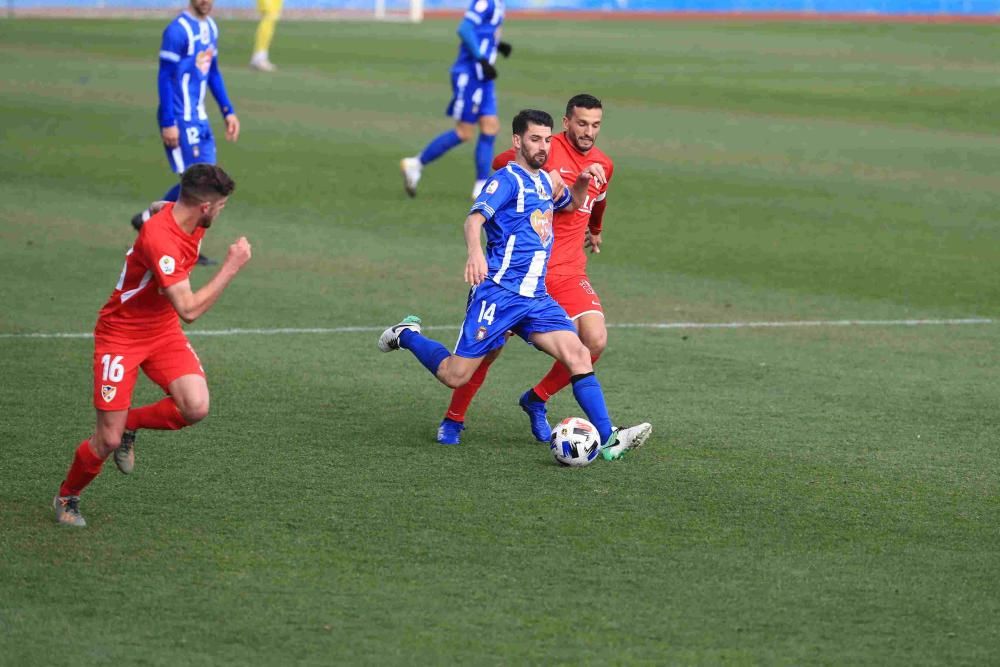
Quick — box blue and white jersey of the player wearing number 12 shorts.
[157,11,234,127]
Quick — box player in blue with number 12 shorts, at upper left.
[132,0,240,264]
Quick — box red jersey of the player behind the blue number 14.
[493,132,614,276]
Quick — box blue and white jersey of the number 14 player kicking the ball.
[470,162,573,297]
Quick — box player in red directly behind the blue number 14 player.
[437,94,614,445]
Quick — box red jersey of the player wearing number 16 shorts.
[95,204,206,338]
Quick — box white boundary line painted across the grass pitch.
[0,317,996,340]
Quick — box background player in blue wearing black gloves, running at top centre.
[399,0,511,198]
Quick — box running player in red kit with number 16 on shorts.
[53,163,250,527]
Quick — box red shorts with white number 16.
[94,327,205,412]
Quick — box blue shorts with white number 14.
[455,280,576,359]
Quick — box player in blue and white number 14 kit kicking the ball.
[378,109,653,460]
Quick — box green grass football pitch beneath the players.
[0,15,1000,666]
